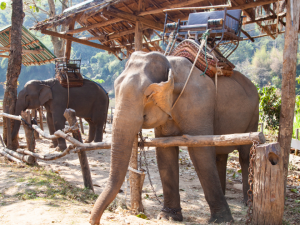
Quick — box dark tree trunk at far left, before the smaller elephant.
[3,0,25,149]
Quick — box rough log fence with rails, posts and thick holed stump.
[0,109,284,224]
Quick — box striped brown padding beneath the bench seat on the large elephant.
[170,39,235,77]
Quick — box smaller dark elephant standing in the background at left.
[12,79,109,150]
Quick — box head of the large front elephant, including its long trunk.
[90,52,174,224]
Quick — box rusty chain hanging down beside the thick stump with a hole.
[246,141,259,224]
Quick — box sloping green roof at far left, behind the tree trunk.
[0,25,56,66]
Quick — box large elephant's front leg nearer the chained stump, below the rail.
[189,147,233,223]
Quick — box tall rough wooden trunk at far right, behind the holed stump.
[279,0,300,197]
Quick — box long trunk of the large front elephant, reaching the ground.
[90,104,143,225]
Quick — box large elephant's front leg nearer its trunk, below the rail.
[156,147,183,221]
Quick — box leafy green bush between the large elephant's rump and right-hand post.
[258,85,281,131]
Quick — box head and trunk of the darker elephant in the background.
[12,80,52,139]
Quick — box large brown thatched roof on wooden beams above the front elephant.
[31,0,292,54]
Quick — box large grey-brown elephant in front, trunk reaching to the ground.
[90,51,259,225]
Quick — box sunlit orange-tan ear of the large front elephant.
[144,69,174,116]
